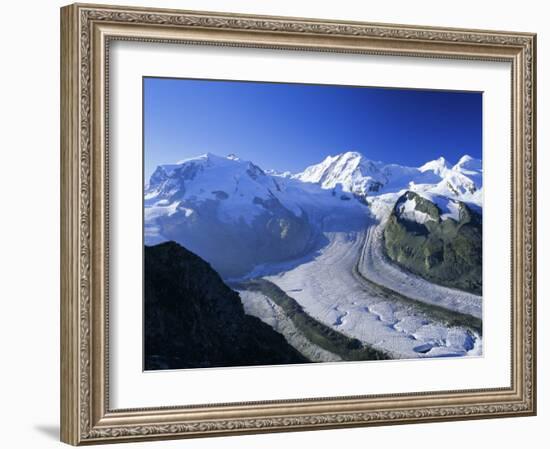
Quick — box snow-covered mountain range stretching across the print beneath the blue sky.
[144,151,483,278]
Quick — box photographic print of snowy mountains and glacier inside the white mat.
[143,77,483,370]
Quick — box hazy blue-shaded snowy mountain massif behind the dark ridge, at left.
[144,154,367,277]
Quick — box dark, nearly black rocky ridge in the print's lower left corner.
[144,242,308,370]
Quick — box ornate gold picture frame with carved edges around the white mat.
[61,4,536,445]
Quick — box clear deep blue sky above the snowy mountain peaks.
[143,78,482,178]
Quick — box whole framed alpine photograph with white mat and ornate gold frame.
[61,4,536,445]
